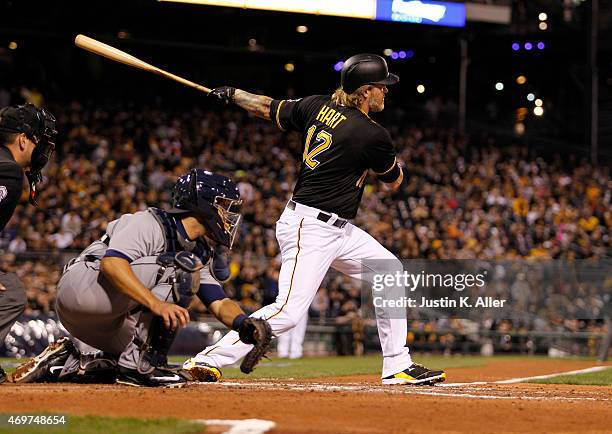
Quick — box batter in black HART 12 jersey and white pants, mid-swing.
[184,54,446,384]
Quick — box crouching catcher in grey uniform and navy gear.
[13,169,272,387]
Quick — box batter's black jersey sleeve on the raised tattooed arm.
[270,95,325,132]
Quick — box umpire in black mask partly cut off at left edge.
[0,104,57,383]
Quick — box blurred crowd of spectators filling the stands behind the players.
[0,90,612,344]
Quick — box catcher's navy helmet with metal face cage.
[169,169,242,248]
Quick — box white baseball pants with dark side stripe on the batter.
[189,204,412,377]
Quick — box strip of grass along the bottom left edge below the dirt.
[0,413,205,434]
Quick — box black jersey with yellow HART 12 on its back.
[270,95,399,219]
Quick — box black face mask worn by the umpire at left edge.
[0,104,57,205]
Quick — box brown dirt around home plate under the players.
[0,359,612,433]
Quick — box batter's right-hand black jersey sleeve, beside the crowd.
[363,130,402,183]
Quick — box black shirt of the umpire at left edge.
[0,146,24,231]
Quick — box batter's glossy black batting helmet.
[340,54,399,94]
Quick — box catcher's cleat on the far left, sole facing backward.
[12,338,75,383]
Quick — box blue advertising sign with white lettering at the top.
[376,0,465,27]
